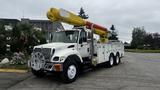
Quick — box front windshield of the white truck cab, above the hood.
[52,31,78,43]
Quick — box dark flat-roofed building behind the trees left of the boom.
[0,18,64,41]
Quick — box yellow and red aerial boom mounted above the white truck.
[47,8,109,42]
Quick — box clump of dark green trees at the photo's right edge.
[131,27,160,49]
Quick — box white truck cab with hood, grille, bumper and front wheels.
[29,29,90,81]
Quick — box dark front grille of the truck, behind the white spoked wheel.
[33,48,51,59]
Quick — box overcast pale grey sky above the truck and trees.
[0,0,160,42]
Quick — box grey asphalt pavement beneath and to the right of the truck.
[2,52,160,90]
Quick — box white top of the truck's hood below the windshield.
[34,42,76,48]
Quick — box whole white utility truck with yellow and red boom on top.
[28,8,124,83]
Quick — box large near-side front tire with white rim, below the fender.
[61,60,79,83]
